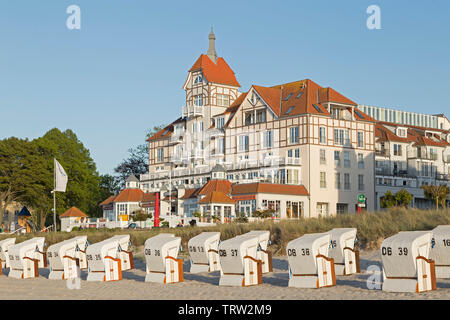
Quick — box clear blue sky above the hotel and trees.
[0,0,450,173]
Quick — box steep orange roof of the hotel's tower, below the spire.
[189,54,241,87]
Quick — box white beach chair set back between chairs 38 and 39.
[328,228,361,276]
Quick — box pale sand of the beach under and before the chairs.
[0,250,450,300]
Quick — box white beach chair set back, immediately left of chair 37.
[188,232,220,273]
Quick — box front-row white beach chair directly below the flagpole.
[47,236,87,280]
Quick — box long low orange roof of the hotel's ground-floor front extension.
[231,182,309,196]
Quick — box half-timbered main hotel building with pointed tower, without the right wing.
[140,31,376,218]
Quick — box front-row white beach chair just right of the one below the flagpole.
[86,238,122,281]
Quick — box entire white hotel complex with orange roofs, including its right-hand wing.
[103,31,450,220]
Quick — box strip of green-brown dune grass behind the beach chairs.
[0,208,450,255]
